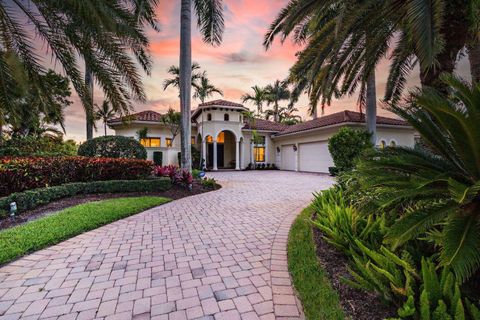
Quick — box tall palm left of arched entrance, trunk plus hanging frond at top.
[179,0,225,170]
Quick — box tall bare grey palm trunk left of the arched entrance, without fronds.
[180,0,192,171]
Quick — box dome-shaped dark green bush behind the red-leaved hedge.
[78,136,147,159]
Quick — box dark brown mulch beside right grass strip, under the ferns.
[313,215,396,320]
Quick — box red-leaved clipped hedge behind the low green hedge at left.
[0,157,153,196]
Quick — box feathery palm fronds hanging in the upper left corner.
[0,0,158,129]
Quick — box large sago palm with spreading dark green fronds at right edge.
[356,75,480,281]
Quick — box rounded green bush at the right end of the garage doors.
[328,127,372,173]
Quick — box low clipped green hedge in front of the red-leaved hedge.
[0,178,172,219]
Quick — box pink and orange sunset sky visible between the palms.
[62,0,468,141]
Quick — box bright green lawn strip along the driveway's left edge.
[0,197,171,264]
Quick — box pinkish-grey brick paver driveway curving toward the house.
[0,171,332,320]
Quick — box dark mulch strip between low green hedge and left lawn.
[0,181,220,230]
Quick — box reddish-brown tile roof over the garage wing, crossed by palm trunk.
[277,110,409,136]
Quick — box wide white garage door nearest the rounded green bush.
[298,141,333,173]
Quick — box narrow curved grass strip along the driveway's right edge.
[288,207,346,320]
